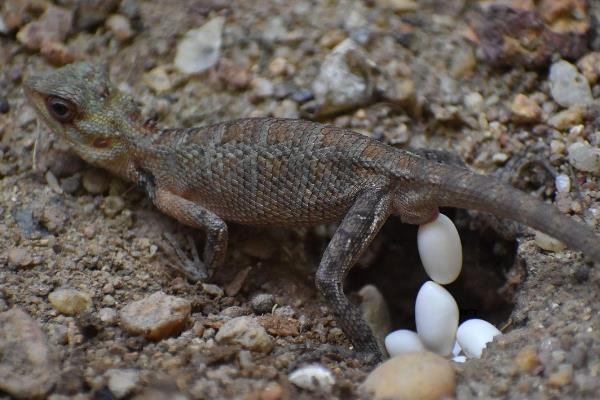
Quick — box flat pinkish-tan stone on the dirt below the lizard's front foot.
[120,292,192,340]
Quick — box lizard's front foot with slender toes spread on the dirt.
[159,232,210,282]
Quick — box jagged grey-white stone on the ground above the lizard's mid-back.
[307,39,375,115]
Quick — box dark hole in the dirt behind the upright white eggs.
[346,210,516,330]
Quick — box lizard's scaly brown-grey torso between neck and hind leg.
[145,118,398,227]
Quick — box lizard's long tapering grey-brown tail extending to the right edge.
[425,163,600,263]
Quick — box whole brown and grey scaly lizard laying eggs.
[25,63,600,359]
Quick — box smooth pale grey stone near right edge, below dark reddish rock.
[549,60,592,107]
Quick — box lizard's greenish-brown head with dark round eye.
[24,62,143,167]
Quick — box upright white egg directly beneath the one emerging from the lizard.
[415,281,458,356]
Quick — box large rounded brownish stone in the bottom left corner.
[0,308,59,399]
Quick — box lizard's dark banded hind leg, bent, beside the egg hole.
[315,189,391,362]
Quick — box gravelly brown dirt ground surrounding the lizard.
[0,0,600,400]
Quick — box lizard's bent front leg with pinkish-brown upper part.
[137,167,228,281]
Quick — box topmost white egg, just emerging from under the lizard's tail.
[417,214,462,285]
